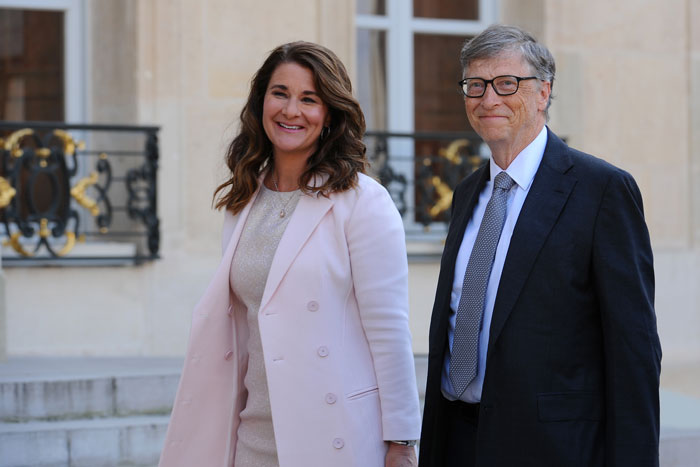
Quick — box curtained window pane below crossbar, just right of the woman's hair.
[356,29,387,130]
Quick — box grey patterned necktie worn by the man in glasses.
[450,172,515,397]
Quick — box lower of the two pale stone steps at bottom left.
[0,416,169,467]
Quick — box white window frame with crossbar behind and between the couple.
[355,0,498,240]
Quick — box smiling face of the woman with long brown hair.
[262,62,330,165]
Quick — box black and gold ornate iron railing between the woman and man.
[365,131,488,235]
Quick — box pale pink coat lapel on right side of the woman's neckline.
[260,194,333,309]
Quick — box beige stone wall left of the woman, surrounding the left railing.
[0,0,354,355]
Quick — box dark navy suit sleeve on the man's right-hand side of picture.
[593,171,661,467]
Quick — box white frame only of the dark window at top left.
[0,0,88,123]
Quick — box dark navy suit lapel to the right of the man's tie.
[489,130,577,352]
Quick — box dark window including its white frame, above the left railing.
[0,0,86,122]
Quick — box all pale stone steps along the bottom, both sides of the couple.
[0,355,700,467]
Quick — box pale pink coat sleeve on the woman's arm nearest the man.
[346,182,420,440]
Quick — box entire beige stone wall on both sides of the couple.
[5,0,700,363]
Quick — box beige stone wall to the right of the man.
[501,0,700,362]
